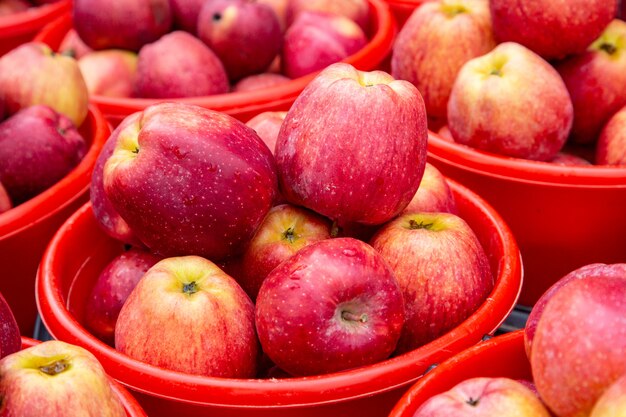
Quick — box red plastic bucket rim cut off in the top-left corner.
[0,0,72,56]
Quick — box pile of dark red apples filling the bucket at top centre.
[64,0,370,98]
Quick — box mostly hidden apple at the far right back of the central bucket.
[401,162,457,214]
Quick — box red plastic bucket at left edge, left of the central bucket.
[0,106,110,335]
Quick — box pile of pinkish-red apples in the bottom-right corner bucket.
[414,264,626,417]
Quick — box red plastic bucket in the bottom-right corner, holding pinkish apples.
[389,330,532,417]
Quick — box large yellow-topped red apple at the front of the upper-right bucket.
[448,42,574,161]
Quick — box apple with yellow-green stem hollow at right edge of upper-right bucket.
[556,19,626,143]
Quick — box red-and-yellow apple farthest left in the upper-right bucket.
[391,0,496,118]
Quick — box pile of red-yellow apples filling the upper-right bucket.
[391,0,626,165]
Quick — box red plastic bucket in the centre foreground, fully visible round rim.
[37,181,522,417]
